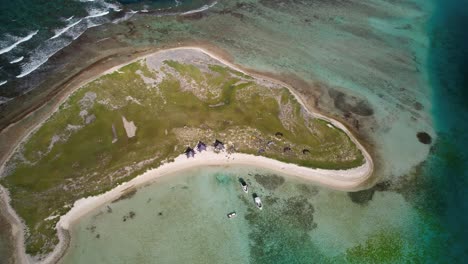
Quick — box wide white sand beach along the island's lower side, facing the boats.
[46,149,373,264]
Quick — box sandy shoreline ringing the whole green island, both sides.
[0,46,374,263]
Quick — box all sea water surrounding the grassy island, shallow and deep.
[0,0,468,263]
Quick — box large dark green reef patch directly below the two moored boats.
[241,192,326,263]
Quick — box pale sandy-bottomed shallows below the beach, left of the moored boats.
[64,166,250,263]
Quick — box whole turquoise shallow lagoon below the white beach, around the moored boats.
[63,167,428,263]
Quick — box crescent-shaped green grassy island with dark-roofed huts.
[0,48,372,258]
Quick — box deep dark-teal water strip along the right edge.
[419,0,468,263]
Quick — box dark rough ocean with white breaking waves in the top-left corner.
[0,0,211,104]
